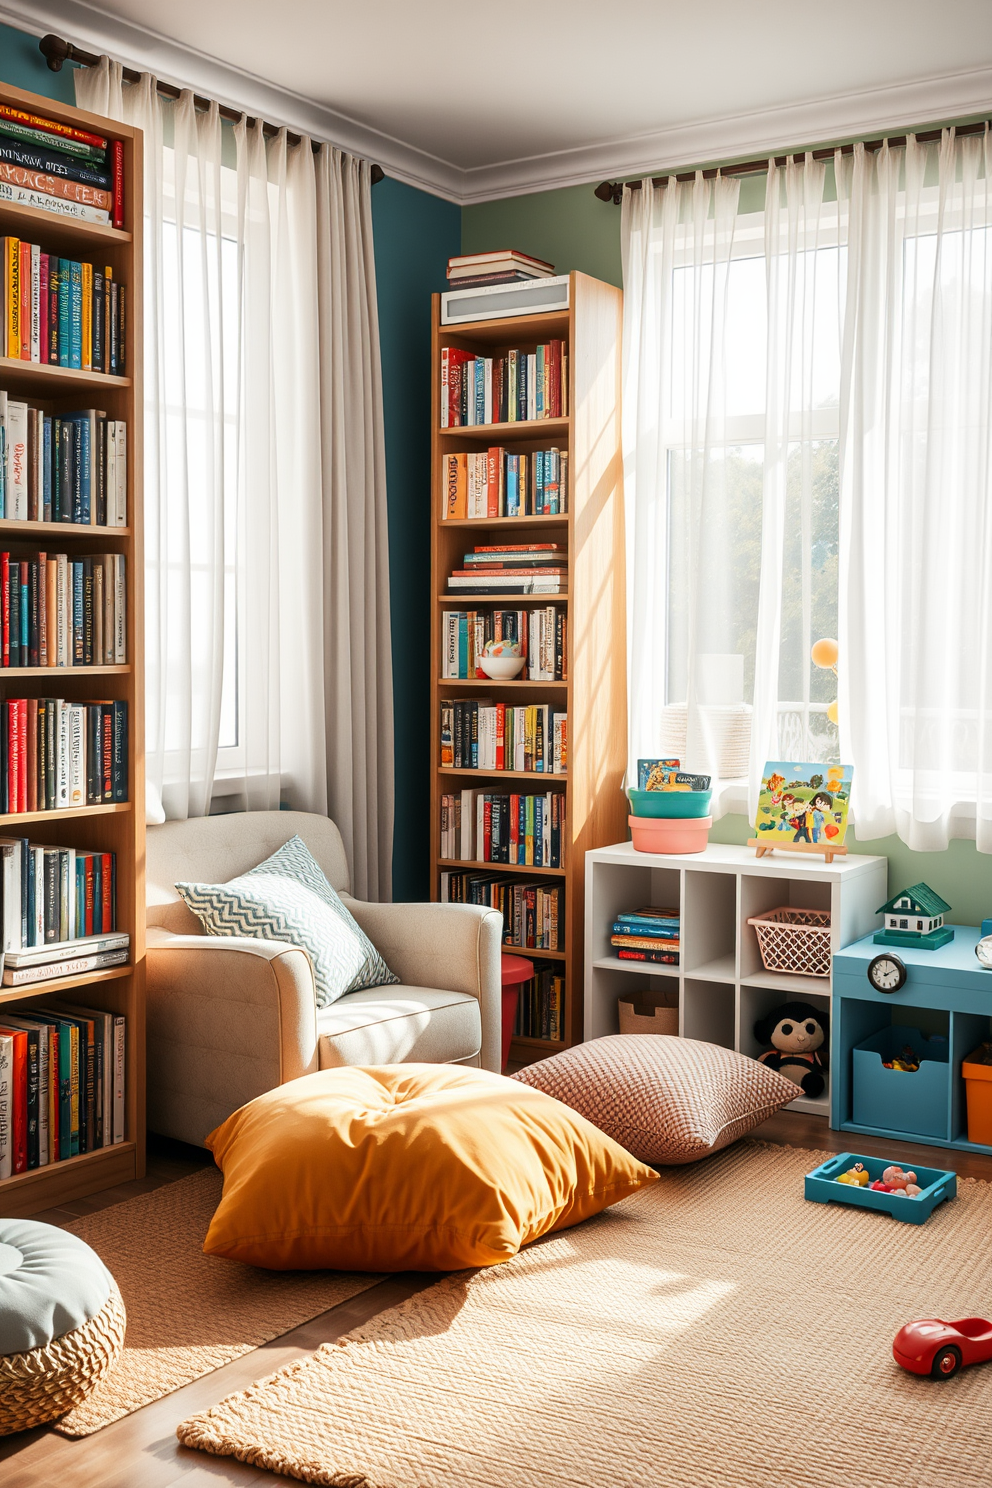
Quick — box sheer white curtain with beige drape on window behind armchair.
[76,58,393,897]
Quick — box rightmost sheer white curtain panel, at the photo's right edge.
[837,126,992,853]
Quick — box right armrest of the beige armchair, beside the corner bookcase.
[349,896,503,1073]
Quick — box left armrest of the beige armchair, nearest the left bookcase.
[146,926,317,1146]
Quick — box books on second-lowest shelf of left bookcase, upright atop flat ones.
[0,836,118,952]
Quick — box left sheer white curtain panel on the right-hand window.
[622,158,842,814]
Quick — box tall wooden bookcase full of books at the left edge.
[0,85,146,1214]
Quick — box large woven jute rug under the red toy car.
[178,1143,992,1488]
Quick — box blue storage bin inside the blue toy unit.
[851,1025,950,1140]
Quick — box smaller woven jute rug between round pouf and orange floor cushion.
[55,1168,382,1436]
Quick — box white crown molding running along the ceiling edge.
[0,0,992,207]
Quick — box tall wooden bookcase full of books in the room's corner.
[431,273,626,1061]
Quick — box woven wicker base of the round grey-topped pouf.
[0,1286,128,1436]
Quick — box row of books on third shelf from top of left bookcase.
[0,391,128,527]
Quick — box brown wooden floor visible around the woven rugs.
[0,1112,992,1488]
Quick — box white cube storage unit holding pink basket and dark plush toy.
[584,842,888,1116]
